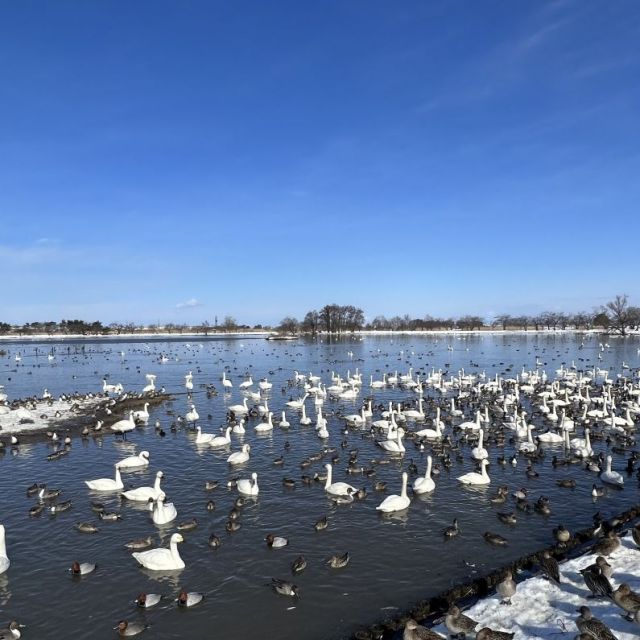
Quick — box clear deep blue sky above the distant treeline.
[0,0,640,323]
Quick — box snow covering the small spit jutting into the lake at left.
[0,396,105,437]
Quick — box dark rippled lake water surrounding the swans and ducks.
[0,334,640,640]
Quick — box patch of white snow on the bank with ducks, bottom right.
[434,533,640,640]
